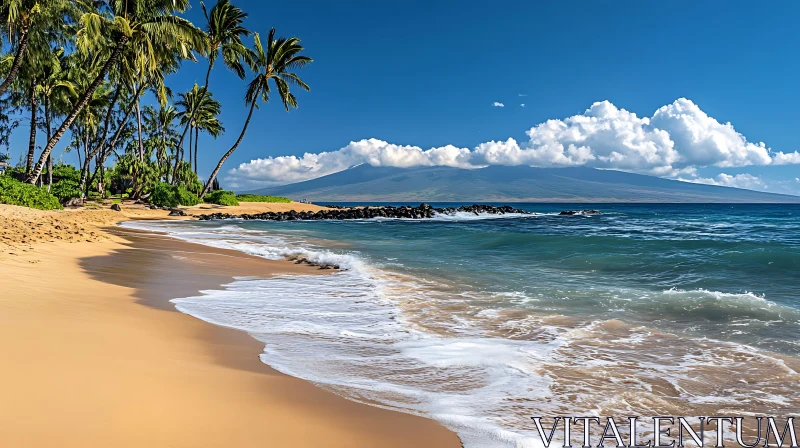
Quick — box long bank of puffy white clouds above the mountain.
[226,98,800,188]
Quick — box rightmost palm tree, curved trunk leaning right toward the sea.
[200,28,313,198]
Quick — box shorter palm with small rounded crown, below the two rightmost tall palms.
[175,84,225,174]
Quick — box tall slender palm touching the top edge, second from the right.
[175,0,253,184]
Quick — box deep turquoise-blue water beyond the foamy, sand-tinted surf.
[290,204,800,355]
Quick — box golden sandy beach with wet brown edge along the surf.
[0,203,460,447]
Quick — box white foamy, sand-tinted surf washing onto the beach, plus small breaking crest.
[119,219,800,448]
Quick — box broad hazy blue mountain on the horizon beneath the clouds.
[254,164,800,203]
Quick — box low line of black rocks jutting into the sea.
[197,204,532,221]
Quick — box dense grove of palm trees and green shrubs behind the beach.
[0,0,312,208]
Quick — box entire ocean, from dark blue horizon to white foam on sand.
[119,204,800,447]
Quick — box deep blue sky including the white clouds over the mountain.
[4,0,800,195]
